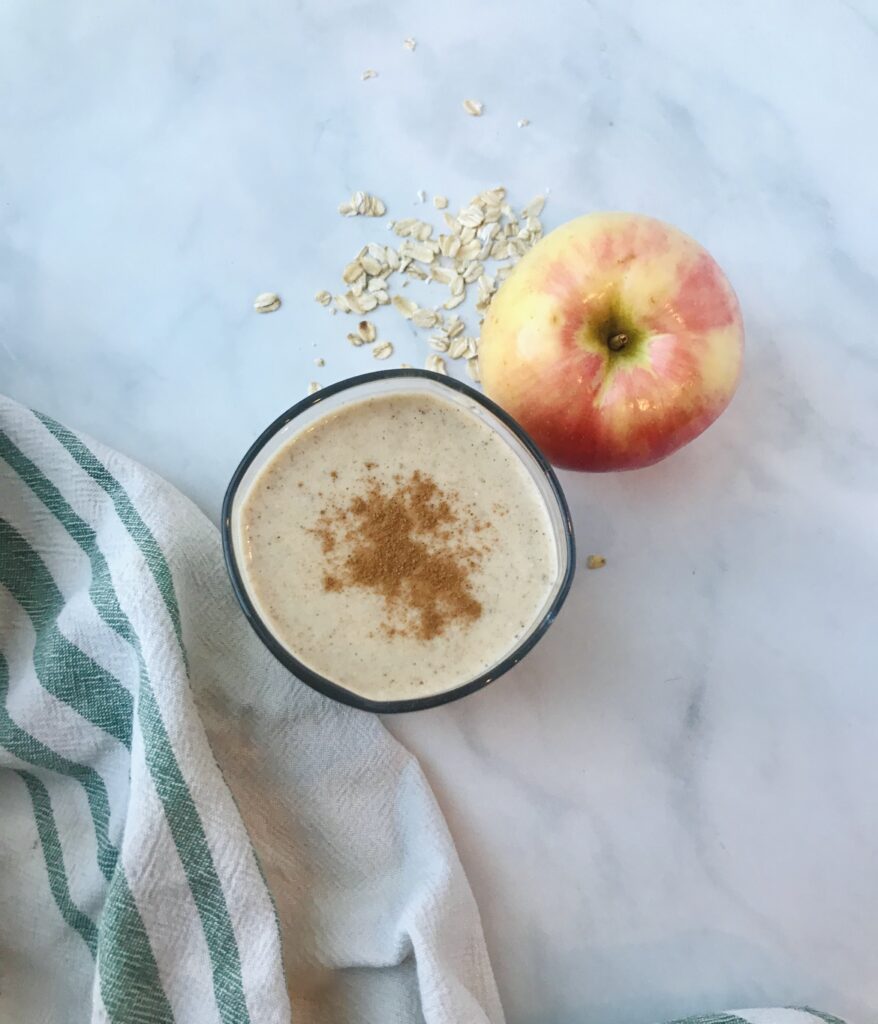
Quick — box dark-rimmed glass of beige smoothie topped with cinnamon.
[222,370,576,713]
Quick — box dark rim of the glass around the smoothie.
[221,370,576,714]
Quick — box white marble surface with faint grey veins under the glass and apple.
[0,0,878,1024]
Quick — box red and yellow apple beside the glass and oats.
[478,213,744,471]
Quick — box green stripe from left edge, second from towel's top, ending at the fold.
[0,430,135,643]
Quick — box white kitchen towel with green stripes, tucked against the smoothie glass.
[0,398,502,1024]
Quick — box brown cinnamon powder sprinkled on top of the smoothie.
[313,470,488,640]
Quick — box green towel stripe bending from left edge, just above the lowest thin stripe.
[0,652,119,881]
